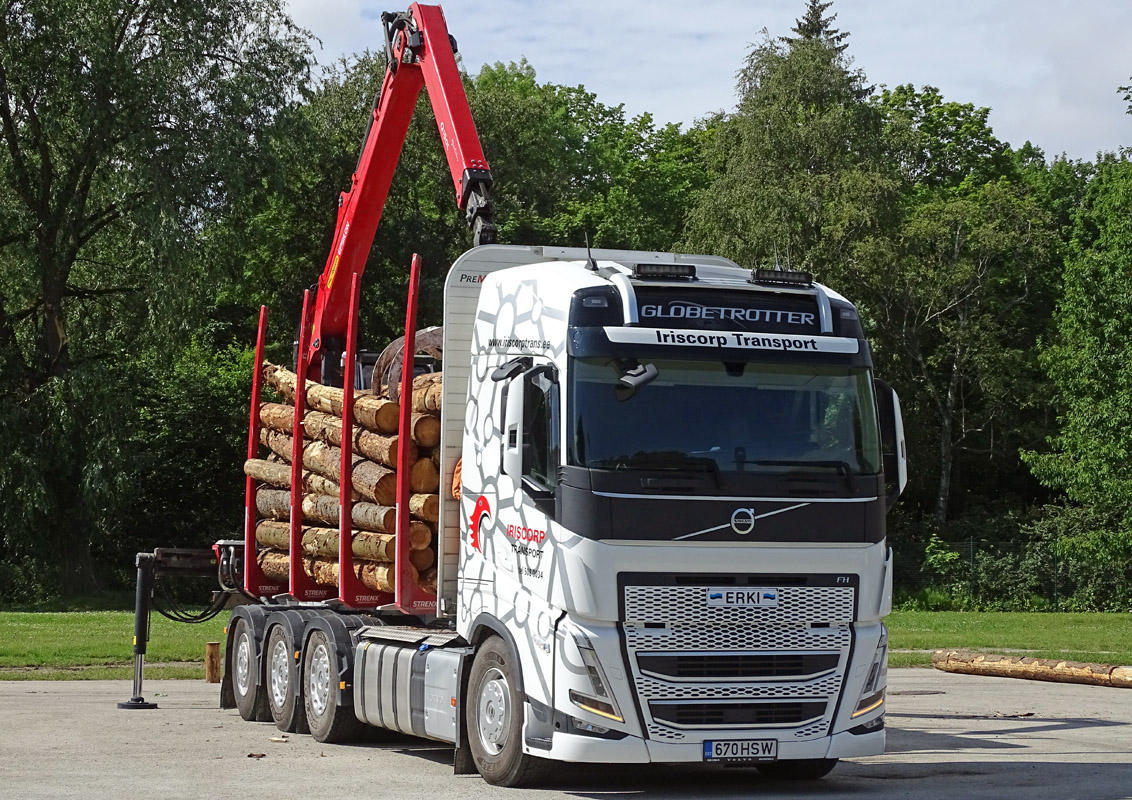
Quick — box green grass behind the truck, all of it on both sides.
[0,611,1132,680]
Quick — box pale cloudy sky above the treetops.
[290,0,1132,161]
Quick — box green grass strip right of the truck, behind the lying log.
[885,611,1132,666]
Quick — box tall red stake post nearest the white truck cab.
[396,253,436,614]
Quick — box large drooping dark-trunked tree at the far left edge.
[0,0,309,592]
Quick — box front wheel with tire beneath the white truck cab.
[464,636,550,786]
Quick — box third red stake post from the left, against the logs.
[338,273,394,609]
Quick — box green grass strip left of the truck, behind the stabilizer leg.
[0,611,229,680]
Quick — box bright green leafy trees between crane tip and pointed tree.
[469,61,703,250]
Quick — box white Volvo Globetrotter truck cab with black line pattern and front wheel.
[439,246,907,776]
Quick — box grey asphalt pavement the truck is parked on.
[0,670,1132,800]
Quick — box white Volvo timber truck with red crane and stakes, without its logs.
[119,5,907,786]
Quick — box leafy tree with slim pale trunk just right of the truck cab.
[850,86,1074,524]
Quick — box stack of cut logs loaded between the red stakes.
[243,362,441,593]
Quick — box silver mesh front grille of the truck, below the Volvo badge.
[623,575,856,741]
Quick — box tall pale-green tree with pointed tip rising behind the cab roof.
[684,3,898,274]
